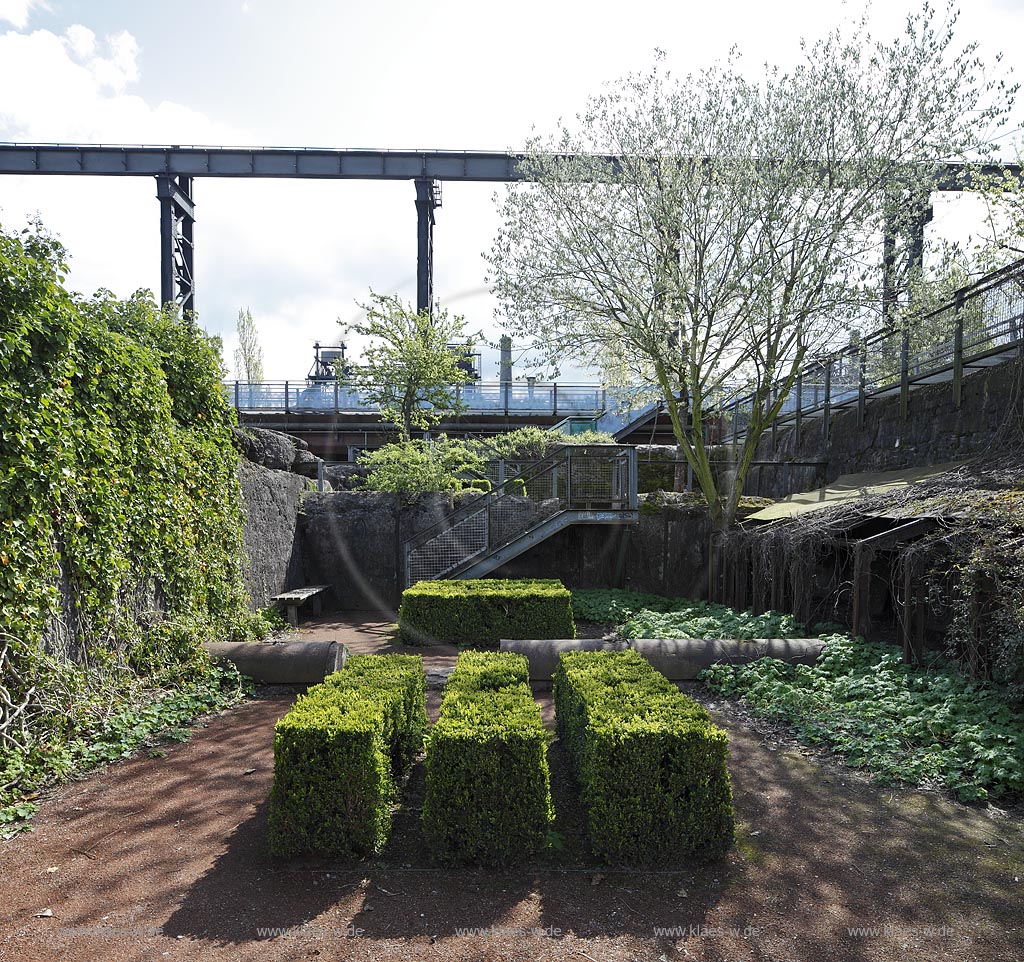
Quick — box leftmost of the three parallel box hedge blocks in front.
[268,655,427,856]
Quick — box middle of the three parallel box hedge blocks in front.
[423,652,554,865]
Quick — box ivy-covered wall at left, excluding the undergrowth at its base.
[0,226,254,661]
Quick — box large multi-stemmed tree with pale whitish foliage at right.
[486,6,1016,530]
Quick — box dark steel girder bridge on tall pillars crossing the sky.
[0,143,1020,312]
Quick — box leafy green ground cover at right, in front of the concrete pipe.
[701,635,1024,801]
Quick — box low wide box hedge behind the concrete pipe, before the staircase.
[398,578,575,644]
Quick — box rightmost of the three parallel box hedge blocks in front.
[554,651,734,863]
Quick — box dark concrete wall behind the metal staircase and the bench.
[233,485,709,611]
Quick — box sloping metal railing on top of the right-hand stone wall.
[717,252,1024,443]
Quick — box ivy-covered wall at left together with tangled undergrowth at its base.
[0,222,266,823]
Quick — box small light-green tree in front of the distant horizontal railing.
[339,291,473,441]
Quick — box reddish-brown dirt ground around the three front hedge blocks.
[0,629,1024,962]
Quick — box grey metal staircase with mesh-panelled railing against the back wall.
[404,445,640,587]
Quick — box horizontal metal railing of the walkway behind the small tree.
[224,380,606,417]
